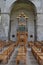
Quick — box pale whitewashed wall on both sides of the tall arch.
[0,0,43,40]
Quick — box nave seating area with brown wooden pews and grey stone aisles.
[0,41,43,65]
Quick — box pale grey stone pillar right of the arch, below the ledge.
[37,13,43,41]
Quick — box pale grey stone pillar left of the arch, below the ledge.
[2,13,10,40]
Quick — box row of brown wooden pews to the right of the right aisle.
[31,42,43,65]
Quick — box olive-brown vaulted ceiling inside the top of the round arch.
[11,0,36,15]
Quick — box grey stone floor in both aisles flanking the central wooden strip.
[0,48,39,65]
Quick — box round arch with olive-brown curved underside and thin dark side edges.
[8,0,37,41]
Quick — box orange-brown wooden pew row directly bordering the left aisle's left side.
[0,44,15,63]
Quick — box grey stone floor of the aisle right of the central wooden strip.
[27,49,39,65]
